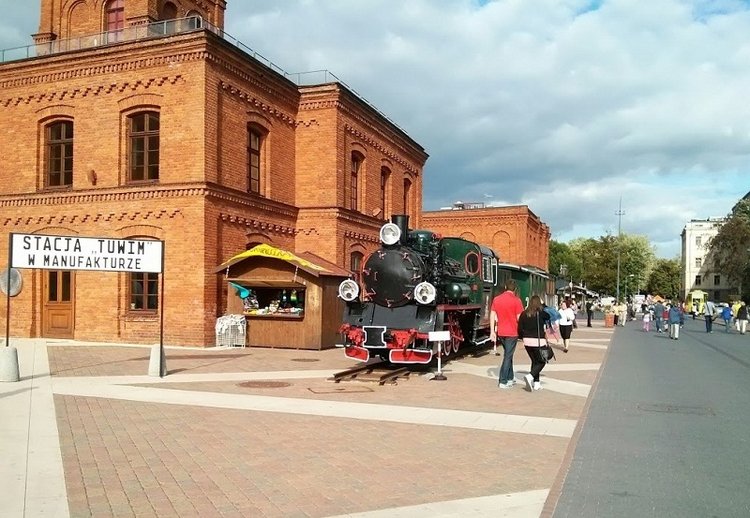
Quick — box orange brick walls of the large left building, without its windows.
[0,20,427,345]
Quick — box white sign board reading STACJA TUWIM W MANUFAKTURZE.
[11,234,164,273]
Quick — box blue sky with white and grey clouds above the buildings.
[0,0,750,258]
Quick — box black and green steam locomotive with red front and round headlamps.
[339,215,502,364]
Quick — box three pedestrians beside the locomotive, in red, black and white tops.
[490,279,576,392]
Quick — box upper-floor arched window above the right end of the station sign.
[128,112,159,182]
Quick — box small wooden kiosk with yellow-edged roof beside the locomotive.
[215,244,350,350]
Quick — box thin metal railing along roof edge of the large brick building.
[0,16,406,133]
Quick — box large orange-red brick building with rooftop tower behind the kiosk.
[0,0,427,345]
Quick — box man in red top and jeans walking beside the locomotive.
[490,279,523,389]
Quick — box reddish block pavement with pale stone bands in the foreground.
[0,322,612,518]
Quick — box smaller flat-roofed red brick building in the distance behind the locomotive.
[422,202,551,270]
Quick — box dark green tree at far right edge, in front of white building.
[709,199,750,297]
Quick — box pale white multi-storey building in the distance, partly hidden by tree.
[681,218,732,302]
